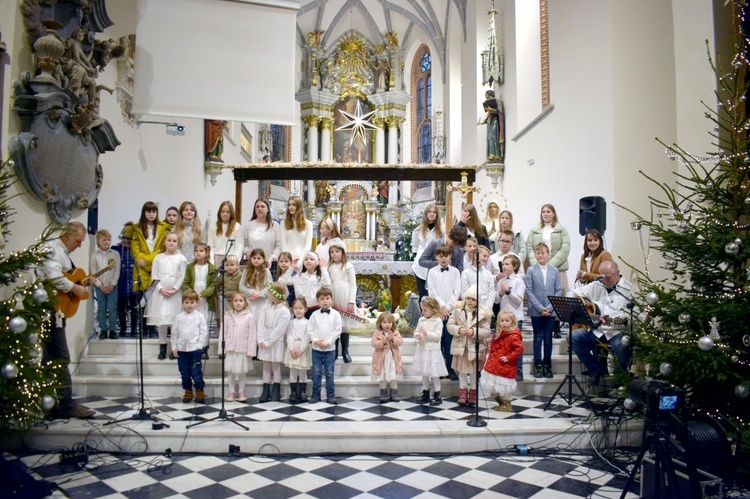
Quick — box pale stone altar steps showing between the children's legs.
[73,334,584,398]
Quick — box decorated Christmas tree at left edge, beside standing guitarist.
[0,158,60,440]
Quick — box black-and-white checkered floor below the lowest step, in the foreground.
[5,451,638,499]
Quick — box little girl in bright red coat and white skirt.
[481,310,523,412]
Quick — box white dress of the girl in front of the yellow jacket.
[146,253,187,326]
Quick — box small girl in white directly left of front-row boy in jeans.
[286,298,312,404]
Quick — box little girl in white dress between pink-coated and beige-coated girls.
[412,296,448,405]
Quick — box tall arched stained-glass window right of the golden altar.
[411,45,433,163]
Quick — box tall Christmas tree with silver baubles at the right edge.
[628,7,750,454]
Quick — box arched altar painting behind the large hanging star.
[333,96,375,163]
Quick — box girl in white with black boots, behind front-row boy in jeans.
[328,240,358,364]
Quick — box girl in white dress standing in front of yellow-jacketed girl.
[146,232,187,360]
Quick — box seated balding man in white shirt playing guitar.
[568,260,632,392]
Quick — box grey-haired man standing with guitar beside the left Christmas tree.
[41,222,94,419]
